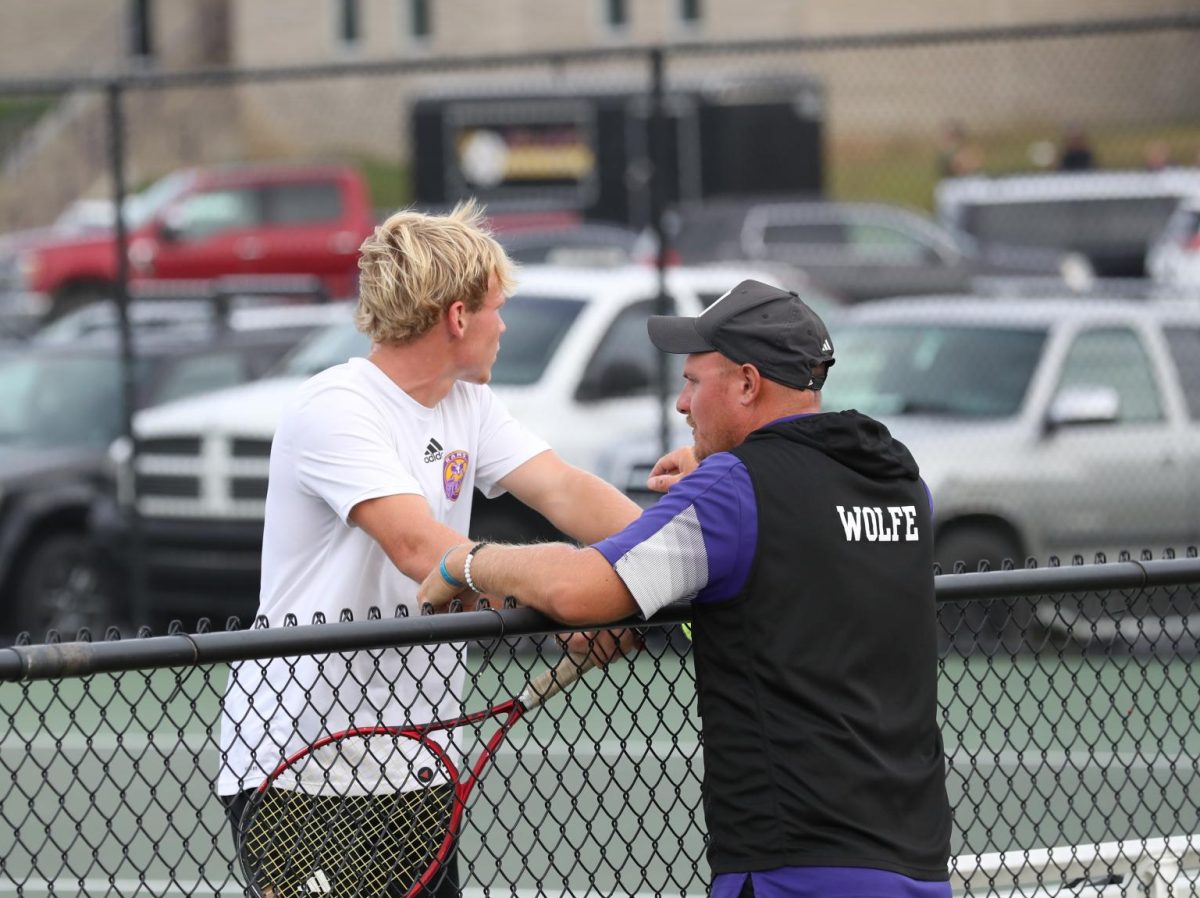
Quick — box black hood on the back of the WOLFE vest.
[746,409,920,480]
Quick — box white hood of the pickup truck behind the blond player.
[134,377,304,439]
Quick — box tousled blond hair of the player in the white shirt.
[354,199,512,343]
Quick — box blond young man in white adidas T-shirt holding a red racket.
[217,203,638,896]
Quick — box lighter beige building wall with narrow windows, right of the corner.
[225,0,1200,164]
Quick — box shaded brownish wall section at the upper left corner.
[0,0,236,228]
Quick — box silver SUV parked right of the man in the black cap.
[602,297,1200,568]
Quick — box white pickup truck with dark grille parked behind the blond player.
[92,265,820,617]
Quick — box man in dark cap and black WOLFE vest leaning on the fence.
[420,281,950,898]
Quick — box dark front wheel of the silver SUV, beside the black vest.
[934,523,1033,654]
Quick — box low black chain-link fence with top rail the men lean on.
[0,557,1200,896]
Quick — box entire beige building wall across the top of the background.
[0,0,1200,223]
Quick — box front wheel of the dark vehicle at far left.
[10,533,118,642]
